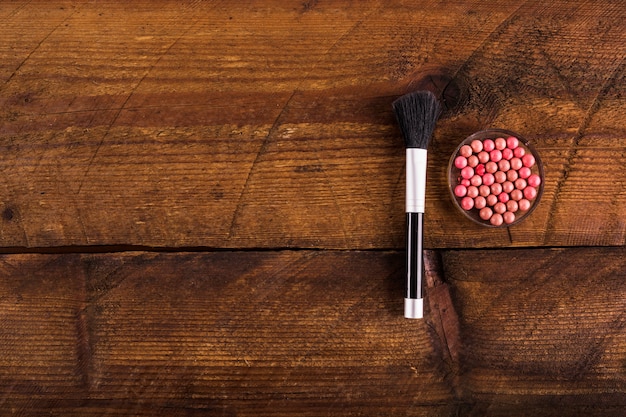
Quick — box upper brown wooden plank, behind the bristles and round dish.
[0,0,626,248]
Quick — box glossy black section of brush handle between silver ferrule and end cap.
[405,213,424,299]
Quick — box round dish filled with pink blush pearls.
[448,129,544,227]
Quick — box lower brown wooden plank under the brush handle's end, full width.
[0,248,626,416]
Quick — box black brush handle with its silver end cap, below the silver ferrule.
[404,213,424,319]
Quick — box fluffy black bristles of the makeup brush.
[393,91,439,149]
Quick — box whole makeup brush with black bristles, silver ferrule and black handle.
[393,91,440,319]
